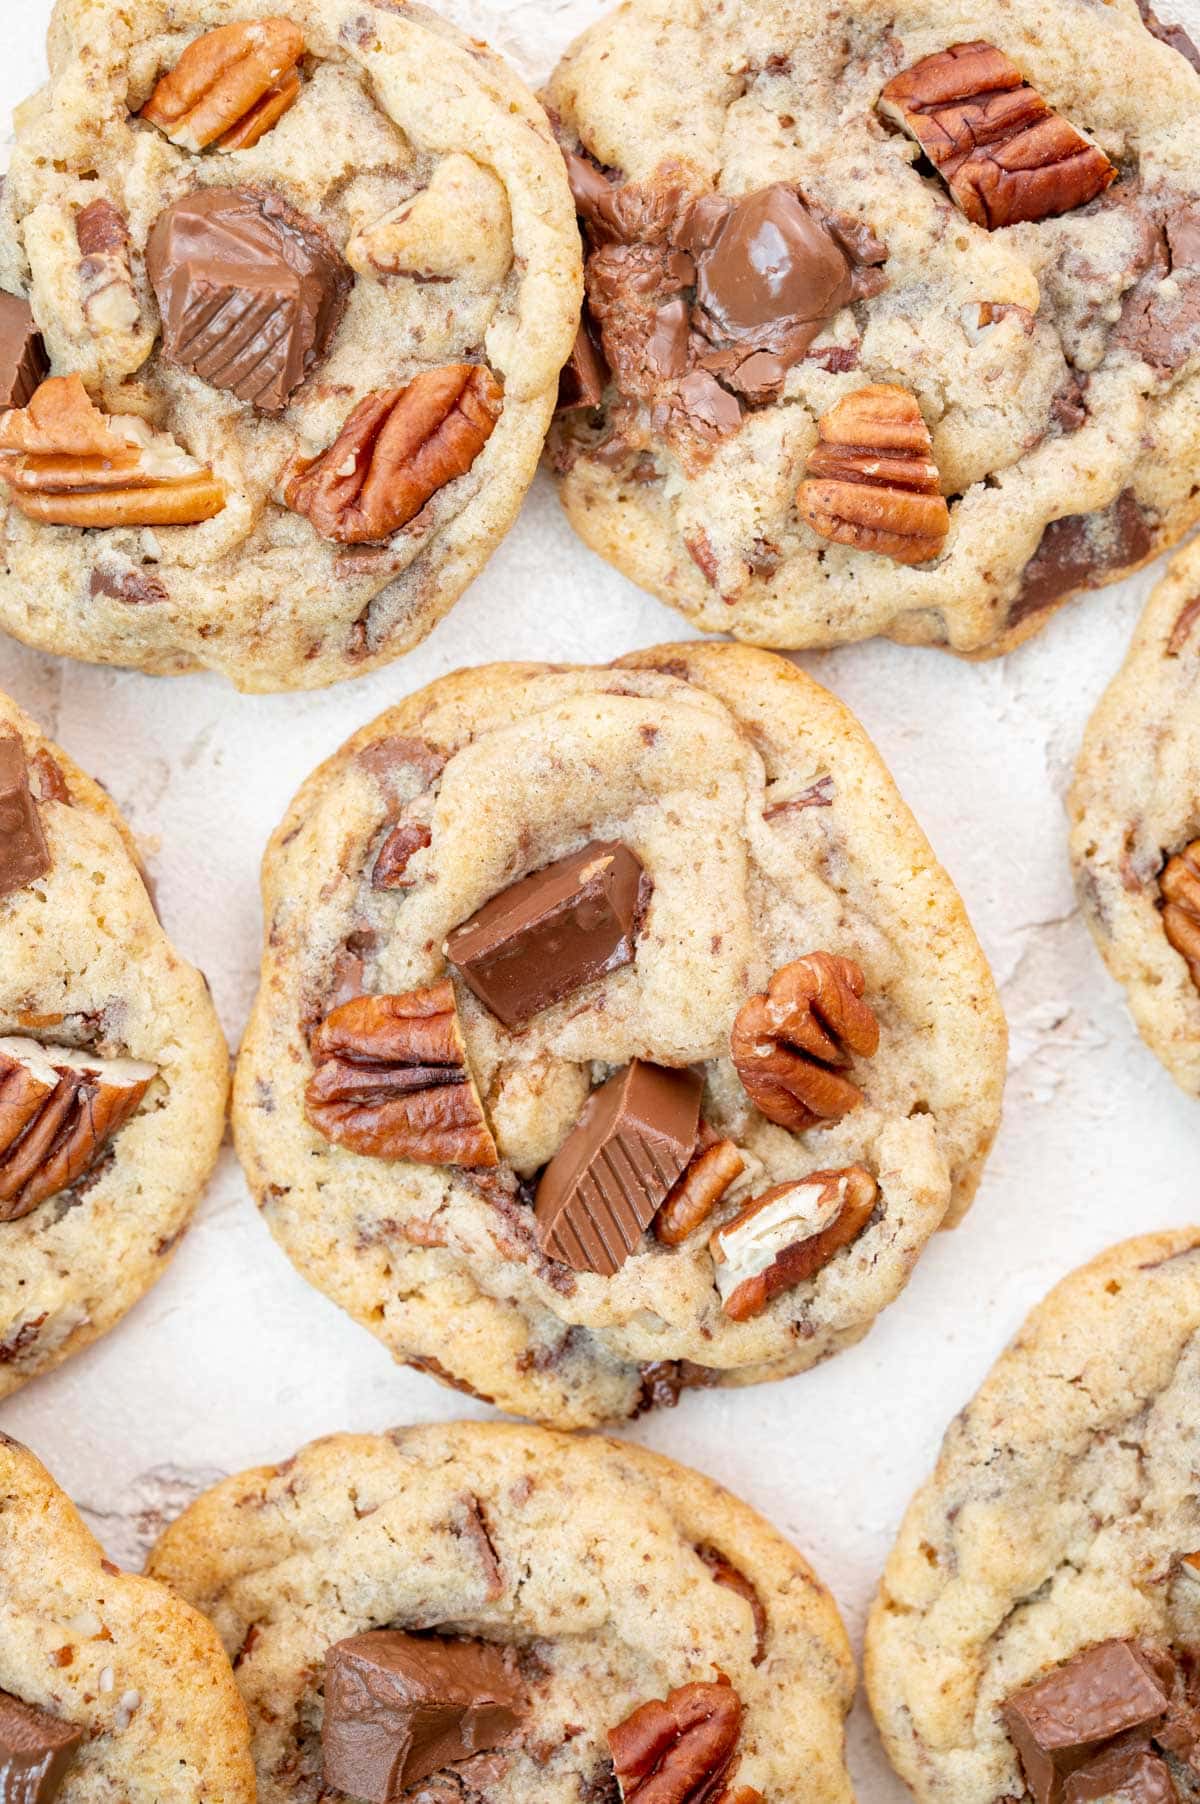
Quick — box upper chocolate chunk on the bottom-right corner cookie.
[1003,1642,1169,1804]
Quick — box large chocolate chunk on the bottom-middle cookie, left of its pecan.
[321,1629,525,1804]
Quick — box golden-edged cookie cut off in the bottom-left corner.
[0,1434,254,1804]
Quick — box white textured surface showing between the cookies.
[0,0,1200,1804]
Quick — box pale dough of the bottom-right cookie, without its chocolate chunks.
[866,1229,1200,1804]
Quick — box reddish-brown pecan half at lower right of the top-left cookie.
[283,363,503,545]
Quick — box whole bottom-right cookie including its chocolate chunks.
[866,1229,1200,1804]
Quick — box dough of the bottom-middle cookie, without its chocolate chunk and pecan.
[150,1423,854,1804]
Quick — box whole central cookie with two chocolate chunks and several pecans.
[235,644,1005,1425]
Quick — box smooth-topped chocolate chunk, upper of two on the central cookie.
[446,841,642,1026]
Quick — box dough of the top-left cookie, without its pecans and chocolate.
[0,0,579,691]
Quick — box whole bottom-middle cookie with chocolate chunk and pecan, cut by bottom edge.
[150,1423,854,1804]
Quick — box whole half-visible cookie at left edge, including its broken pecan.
[0,695,229,1396]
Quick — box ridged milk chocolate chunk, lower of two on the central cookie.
[534,1059,702,1277]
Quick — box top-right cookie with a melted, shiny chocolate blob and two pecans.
[549,0,1200,655]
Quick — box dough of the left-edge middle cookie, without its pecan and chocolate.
[0,695,229,1396]
